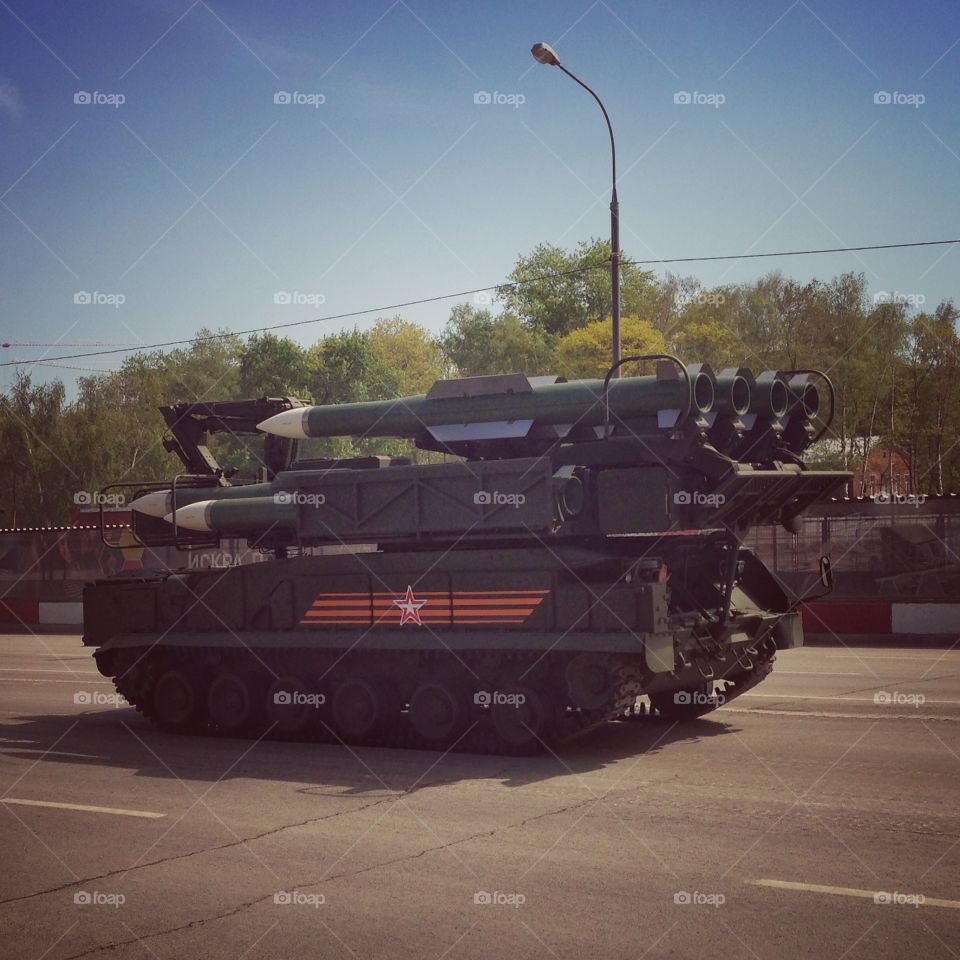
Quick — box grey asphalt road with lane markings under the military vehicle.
[0,636,960,960]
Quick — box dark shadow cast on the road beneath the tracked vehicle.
[0,708,738,796]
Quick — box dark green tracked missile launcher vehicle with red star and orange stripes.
[84,355,849,754]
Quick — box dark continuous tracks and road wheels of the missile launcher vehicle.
[100,646,772,755]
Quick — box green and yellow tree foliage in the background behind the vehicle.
[0,240,960,526]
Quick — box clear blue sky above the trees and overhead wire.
[0,0,960,387]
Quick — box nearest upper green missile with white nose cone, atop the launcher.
[257,365,714,439]
